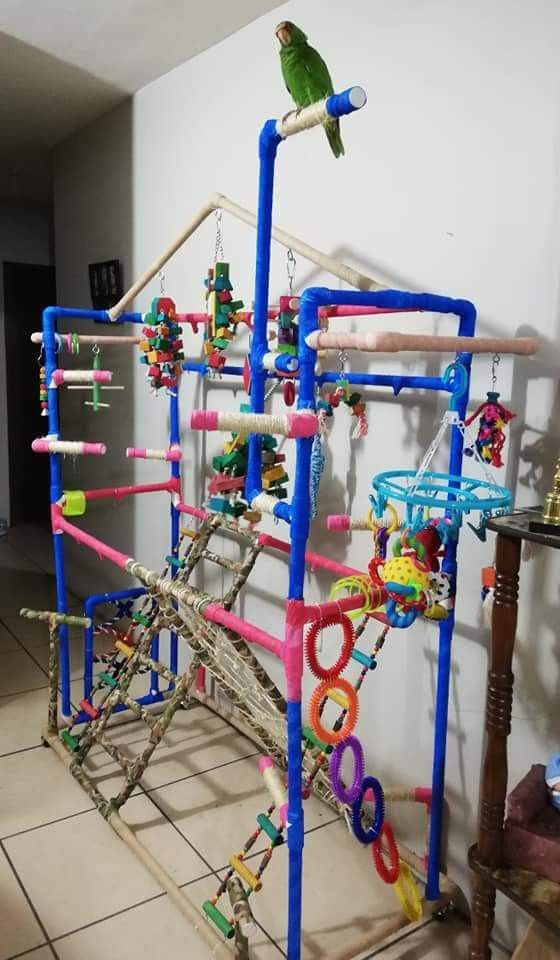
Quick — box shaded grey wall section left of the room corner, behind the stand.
[55,100,136,596]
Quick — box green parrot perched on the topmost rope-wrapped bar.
[276,20,344,157]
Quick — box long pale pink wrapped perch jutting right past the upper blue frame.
[305,330,538,357]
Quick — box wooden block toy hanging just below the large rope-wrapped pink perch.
[208,403,289,522]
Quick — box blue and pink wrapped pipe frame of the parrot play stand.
[31,88,534,960]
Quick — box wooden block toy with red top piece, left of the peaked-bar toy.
[139,296,184,391]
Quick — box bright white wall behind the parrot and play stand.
[56,0,560,942]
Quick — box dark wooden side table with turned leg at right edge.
[469,510,560,960]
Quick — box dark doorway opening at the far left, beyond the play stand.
[3,262,56,526]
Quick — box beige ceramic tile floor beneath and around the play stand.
[0,528,506,960]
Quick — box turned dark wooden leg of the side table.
[469,534,521,960]
